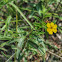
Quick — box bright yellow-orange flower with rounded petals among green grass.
[47,22,57,35]
